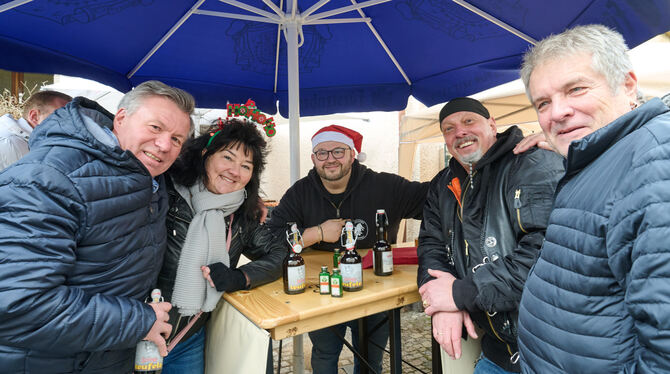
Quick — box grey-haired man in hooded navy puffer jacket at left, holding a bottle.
[0,81,194,374]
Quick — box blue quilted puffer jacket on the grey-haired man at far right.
[519,99,670,374]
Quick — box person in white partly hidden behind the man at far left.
[0,91,72,171]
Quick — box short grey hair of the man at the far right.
[521,25,633,101]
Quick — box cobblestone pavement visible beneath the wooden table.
[273,303,432,374]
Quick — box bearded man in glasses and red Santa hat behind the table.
[268,125,428,374]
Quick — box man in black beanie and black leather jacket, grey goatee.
[417,98,563,373]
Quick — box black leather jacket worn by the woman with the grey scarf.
[157,177,288,341]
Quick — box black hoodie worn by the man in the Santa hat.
[268,160,429,251]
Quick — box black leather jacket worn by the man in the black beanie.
[417,127,563,371]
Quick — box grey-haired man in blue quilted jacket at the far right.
[518,25,670,374]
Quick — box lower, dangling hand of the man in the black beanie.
[433,312,477,359]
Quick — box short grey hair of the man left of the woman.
[118,81,195,134]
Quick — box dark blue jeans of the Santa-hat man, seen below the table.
[309,313,389,374]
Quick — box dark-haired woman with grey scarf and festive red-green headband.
[158,119,286,374]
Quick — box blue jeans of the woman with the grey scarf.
[161,326,205,374]
